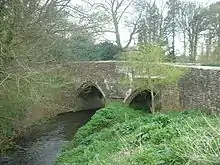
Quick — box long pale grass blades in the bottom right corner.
[172,116,220,165]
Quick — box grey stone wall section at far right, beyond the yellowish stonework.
[179,67,220,112]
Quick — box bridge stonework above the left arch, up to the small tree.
[64,61,127,98]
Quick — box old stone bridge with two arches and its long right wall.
[52,61,220,112]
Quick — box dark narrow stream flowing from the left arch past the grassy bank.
[0,110,97,165]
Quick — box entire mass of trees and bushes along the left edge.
[0,0,77,152]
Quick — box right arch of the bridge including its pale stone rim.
[124,89,159,113]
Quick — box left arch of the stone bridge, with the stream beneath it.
[74,81,106,111]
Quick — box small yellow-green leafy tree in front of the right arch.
[121,44,185,113]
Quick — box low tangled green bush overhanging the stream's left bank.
[0,65,75,153]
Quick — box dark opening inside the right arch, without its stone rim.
[129,90,155,113]
